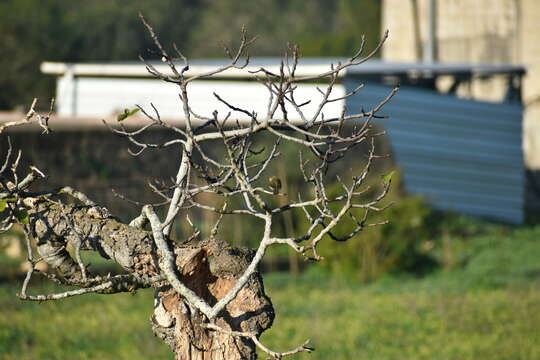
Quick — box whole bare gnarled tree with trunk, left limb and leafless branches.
[0,16,396,359]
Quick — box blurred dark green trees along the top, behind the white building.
[0,0,380,110]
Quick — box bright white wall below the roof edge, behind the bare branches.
[57,74,345,124]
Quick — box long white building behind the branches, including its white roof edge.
[41,59,344,120]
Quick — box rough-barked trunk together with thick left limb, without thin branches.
[26,199,274,360]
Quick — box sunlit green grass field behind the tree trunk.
[0,227,540,360]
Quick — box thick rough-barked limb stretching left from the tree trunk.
[25,199,158,278]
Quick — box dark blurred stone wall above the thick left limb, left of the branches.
[0,128,180,220]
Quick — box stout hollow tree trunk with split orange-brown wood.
[152,239,274,359]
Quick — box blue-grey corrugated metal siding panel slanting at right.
[344,78,524,223]
